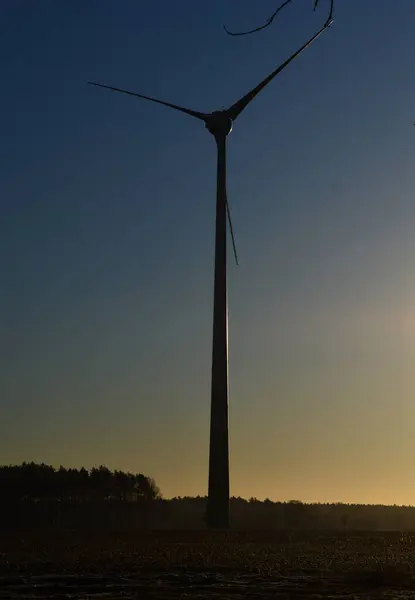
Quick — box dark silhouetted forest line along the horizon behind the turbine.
[0,463,415,534]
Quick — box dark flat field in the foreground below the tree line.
[0,531,415,600]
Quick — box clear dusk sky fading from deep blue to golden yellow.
[0,0,415,504]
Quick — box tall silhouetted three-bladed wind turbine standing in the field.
[88,19,332,529]
